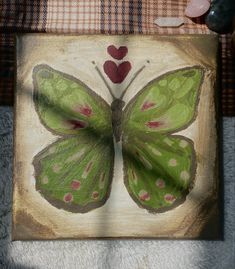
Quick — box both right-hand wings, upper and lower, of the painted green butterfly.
[122,67,203,212]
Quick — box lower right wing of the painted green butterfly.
[123,134,196,212]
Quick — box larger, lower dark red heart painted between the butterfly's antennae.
[103,61,131,83]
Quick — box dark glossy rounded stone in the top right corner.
[206,0,235,33]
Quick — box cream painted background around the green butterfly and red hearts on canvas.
[13,34,216,239]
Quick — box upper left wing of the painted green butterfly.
[33,65,112,136]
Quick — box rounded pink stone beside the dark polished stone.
[185,0,210,18]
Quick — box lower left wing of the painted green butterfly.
[33,134,114,213]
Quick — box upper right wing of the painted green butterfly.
[123,67,203,134]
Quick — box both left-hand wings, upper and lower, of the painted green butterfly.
[33,65,114,213]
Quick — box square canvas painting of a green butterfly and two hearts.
[12,34,220,240]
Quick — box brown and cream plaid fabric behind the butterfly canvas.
[0,0,235,116]
